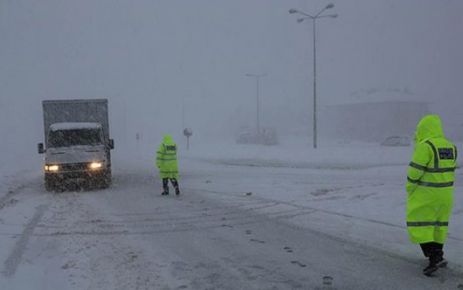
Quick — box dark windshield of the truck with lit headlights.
[48,129,102,147]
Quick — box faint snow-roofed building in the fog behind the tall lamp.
[321,90,429,142]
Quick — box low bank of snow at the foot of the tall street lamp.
[185,139,413,169]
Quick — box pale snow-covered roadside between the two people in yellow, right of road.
[174,138,463,271]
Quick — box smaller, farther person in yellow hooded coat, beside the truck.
[156,135,180,195]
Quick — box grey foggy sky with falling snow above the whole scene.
[0,0,463,170]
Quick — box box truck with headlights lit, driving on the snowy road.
[38,99,114,191]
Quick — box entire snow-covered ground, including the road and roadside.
[0,139,463,289]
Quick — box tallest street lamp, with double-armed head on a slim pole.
[289,3,338,148]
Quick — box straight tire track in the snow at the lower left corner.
[3,205,47,277]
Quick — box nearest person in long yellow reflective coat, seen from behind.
[406,115,457,276]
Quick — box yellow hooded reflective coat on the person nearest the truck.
[156,135,179,179]
